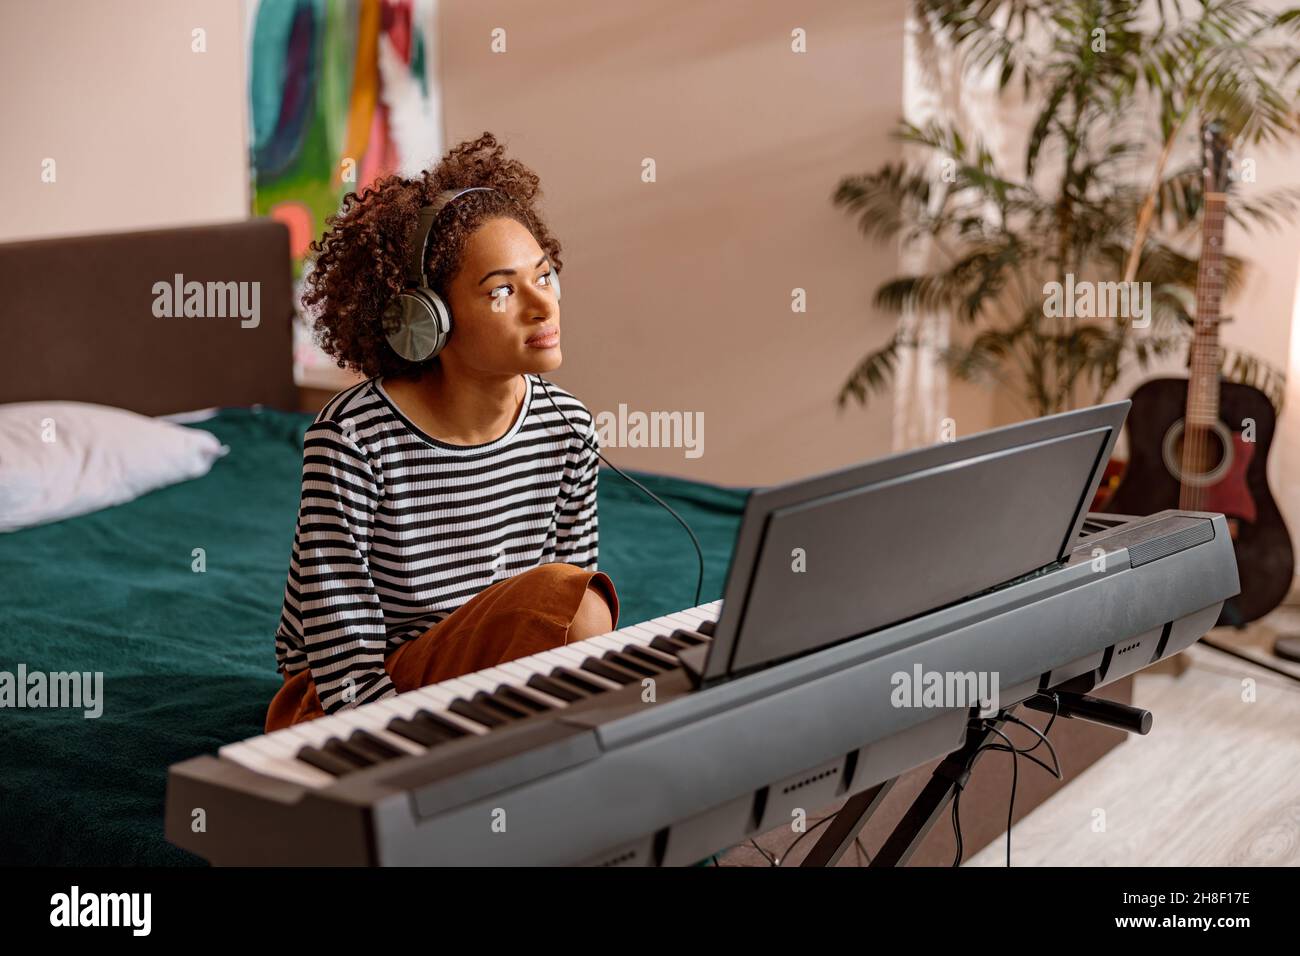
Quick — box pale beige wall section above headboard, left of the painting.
[0,0,248,241]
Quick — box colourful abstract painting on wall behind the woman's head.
[246,0,442,388]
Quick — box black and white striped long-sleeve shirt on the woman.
[276,375,599,714]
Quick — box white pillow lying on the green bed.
[0,402,230,532]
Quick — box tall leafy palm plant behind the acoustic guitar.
[833,0,1300,415]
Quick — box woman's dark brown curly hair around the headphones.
[303,133,563,377]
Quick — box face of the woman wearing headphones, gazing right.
[442,219,562,375]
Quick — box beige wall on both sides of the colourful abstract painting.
[0,0,904,485]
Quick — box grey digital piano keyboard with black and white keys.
[165,511,1238,865]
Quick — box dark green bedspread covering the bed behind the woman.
[0,408,748,865]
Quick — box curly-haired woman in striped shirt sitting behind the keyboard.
[265,133,619,732]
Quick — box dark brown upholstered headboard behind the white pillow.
[0,219,298,415]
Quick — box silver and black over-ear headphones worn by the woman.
[384,186,560,362]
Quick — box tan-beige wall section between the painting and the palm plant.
[441,0,904,484]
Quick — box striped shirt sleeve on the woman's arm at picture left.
[290,421,397,714]
